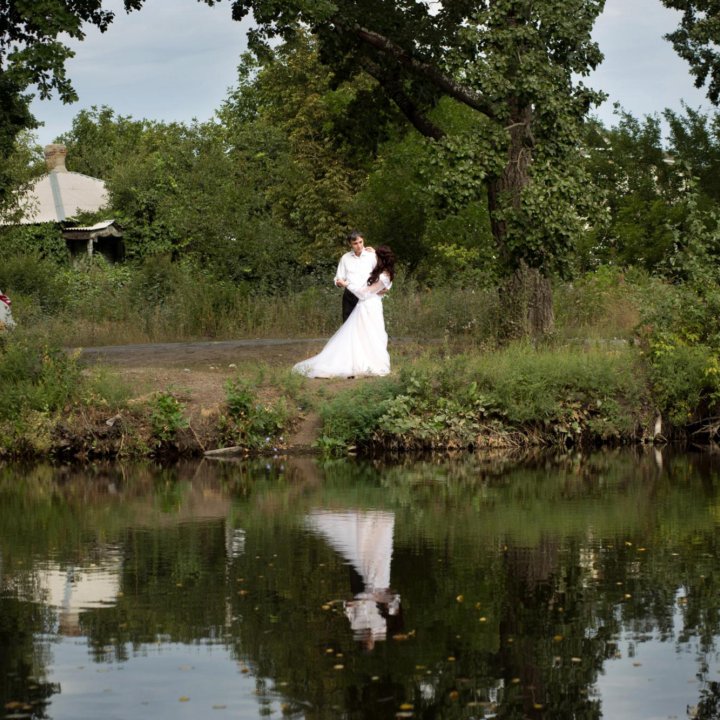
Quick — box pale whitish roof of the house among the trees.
[13,169,108,225]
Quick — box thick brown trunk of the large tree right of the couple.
[488,106,555,340]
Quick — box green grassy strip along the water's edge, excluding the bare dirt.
[0,335,672,460]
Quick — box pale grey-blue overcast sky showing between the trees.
[33,0,710,145]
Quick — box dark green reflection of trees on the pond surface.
[5,453,720,718]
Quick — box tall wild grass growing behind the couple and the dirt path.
[0,258,654,348]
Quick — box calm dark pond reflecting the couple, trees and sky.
[0,449,720,720]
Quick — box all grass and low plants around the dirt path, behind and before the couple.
[0,268,720,459]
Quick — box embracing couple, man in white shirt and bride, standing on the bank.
[293,231,395,378]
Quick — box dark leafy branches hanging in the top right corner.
[662,0,720,105]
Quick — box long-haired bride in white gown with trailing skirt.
[293,245,395,378]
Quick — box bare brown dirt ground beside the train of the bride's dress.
[79,338,363,451]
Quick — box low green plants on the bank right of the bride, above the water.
[322,345,649,449]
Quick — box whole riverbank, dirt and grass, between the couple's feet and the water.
[0,339,678,462]
